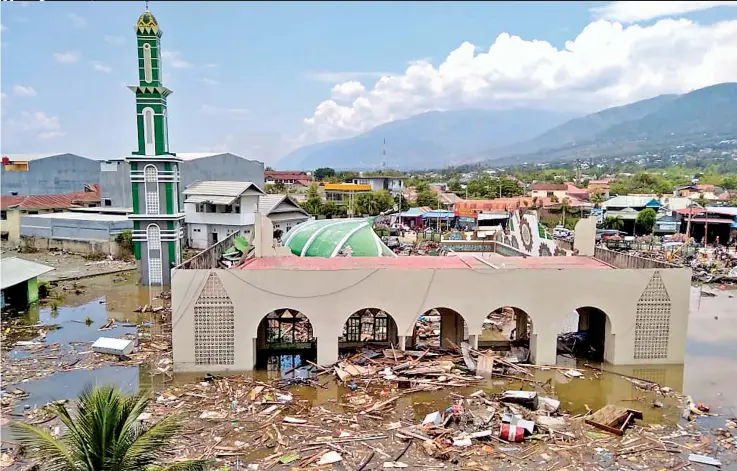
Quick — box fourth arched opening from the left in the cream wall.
[479,306,535,362]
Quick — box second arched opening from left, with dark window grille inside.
[338,308,399,349]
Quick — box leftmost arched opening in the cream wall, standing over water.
[256,309,317,378]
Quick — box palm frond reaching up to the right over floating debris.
[120,415,180,470]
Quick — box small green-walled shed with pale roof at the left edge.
[0,257,54,310]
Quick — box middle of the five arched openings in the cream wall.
[409,307,468,350]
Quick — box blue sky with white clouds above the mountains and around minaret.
[0,1,737,164]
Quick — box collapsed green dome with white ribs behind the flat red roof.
[282,218,396,258]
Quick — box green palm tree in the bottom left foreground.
[10,386,210,471]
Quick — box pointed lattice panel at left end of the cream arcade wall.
[194,273,235,365]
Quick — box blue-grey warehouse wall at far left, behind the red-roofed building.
[0,154,100,195]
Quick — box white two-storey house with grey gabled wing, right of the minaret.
[182,181,310,249]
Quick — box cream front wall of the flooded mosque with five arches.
[172,268,691,371]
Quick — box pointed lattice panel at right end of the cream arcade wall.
[635,271,671,360]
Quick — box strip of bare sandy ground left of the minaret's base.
[2,250,136,281]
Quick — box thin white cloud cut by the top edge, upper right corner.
[589,1,737,23]
